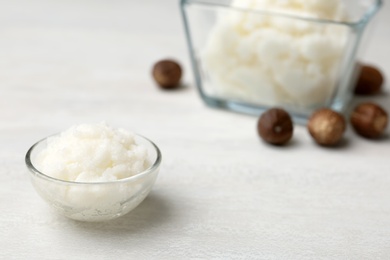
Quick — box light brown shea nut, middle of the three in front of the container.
[307,108,346,146]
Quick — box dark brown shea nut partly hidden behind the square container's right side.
[355,65,384,95]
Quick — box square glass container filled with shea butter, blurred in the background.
[181,0,382,122]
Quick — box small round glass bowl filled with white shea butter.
[26,124,161,221]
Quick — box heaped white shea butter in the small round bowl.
[35,123,149,182]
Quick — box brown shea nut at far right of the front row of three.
[351,103,388,138]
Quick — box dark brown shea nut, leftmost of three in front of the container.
[257,108,294,145]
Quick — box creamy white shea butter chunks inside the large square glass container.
[201,0,348,108]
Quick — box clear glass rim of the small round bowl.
[25,133,162,185]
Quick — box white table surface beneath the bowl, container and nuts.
[0,0,390,259]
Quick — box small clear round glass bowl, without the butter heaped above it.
[25,135,161,222]
